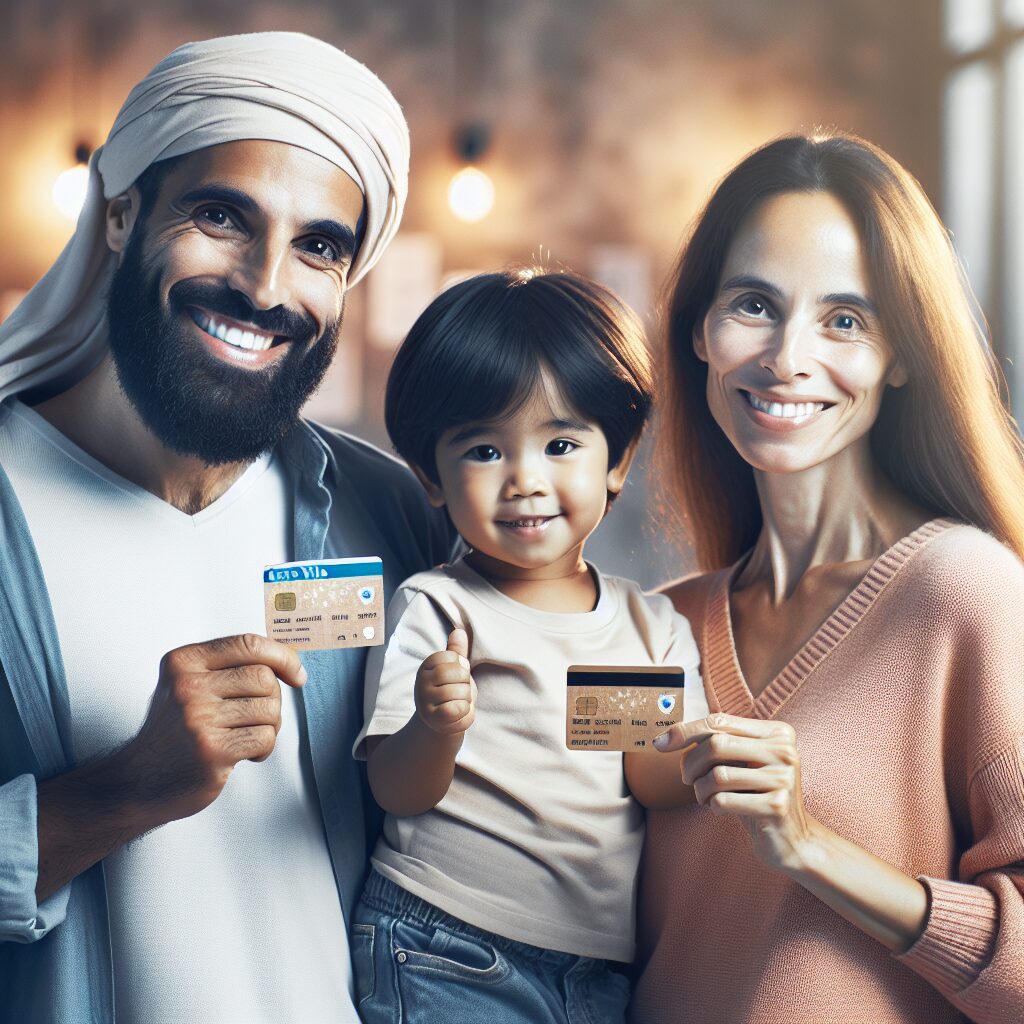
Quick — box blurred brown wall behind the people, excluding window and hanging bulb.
[0,0,942,584]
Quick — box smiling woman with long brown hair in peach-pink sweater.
[630,136,1024,1024]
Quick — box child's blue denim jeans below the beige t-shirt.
[351,871,630,1024]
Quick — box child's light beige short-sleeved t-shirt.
[355,561,705,961]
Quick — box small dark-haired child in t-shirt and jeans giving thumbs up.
[352,271,702,1024]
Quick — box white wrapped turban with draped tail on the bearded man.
[0,32,409,399]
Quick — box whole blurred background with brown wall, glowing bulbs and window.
[0,0,1024,586]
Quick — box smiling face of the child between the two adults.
[417,377,630,579]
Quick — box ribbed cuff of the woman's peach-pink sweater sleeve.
[897,876,999,992]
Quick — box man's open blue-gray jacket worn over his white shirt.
[0,415,453,1024]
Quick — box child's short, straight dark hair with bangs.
[384,268,653,482]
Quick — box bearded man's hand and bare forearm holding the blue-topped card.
[36,633,306,900]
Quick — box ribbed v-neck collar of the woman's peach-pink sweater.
[702,519,959,719]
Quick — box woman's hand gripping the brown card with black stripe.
[654,714,817,870]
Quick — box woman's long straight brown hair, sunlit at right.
[659,134,1024,569]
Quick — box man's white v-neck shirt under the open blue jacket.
[0,402,357,1024]
